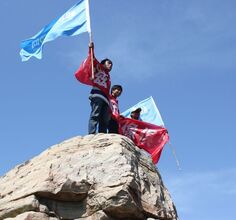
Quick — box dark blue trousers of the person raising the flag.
[88,97,110,134]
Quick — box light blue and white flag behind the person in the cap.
[121,96,164,127]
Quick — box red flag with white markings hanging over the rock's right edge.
[118,117,169,164]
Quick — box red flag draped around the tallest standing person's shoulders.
[75,49,111,96]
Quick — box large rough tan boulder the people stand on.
[0,134,177,220]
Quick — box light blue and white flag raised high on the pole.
[20,0,91,61]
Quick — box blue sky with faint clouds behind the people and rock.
[0,0,236,220]
